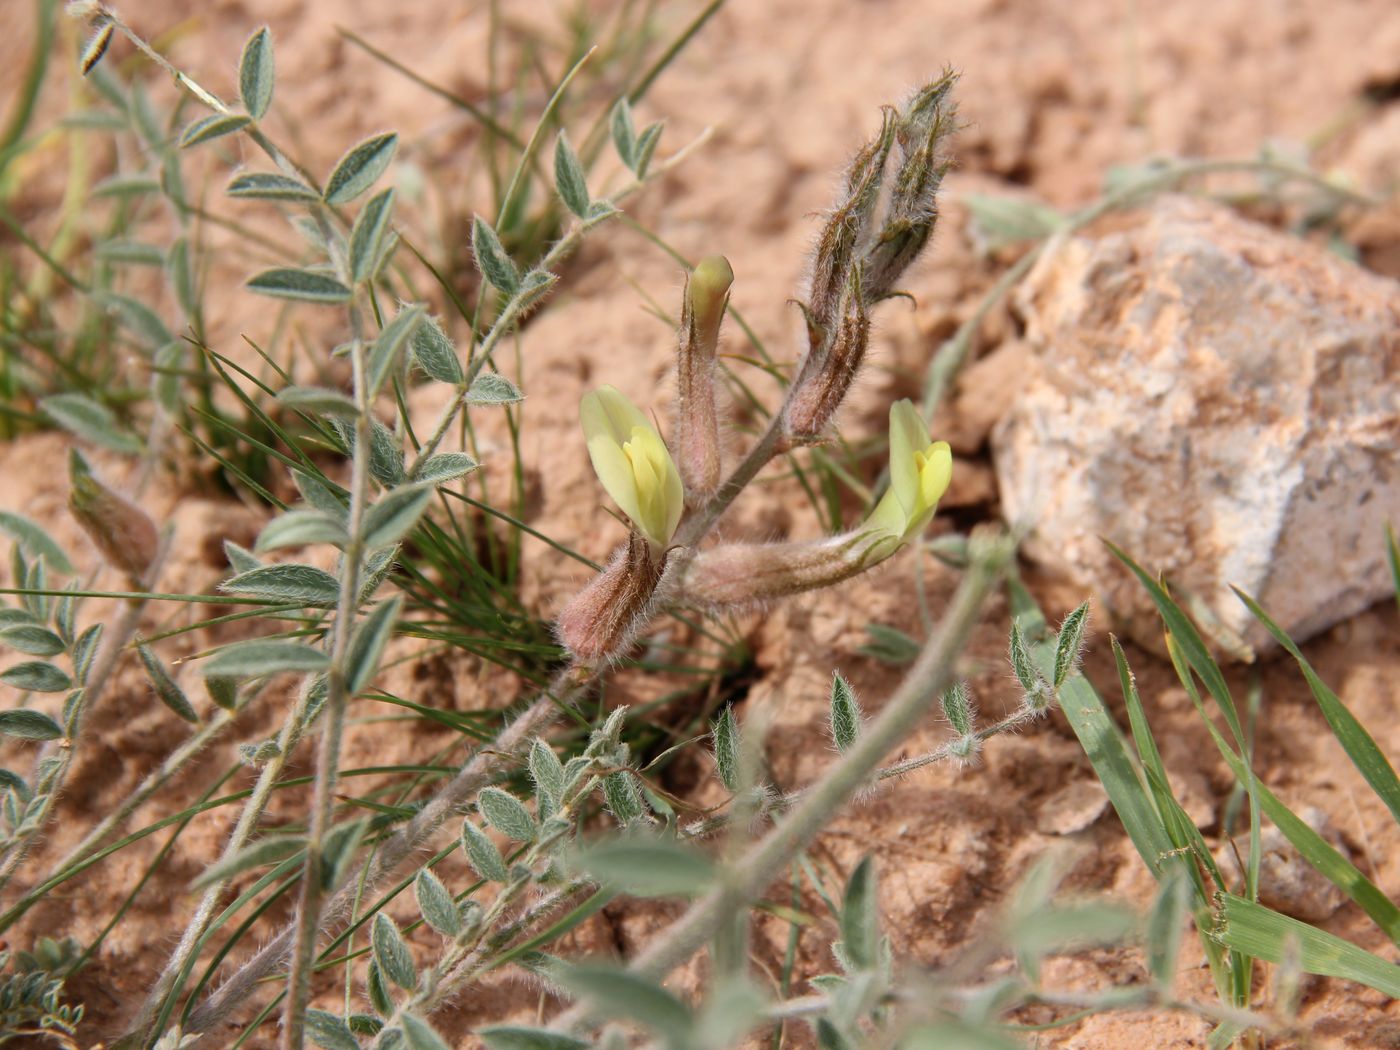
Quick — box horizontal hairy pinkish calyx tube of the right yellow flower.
[682,531,896,609]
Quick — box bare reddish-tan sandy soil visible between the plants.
[0,0,1400,1049]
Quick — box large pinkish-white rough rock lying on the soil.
[993,197,1400,658]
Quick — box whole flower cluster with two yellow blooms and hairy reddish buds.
[557,74,956,665]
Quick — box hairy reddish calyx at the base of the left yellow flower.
[556,532,668,664]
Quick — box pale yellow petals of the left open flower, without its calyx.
[578,386,685,547]
